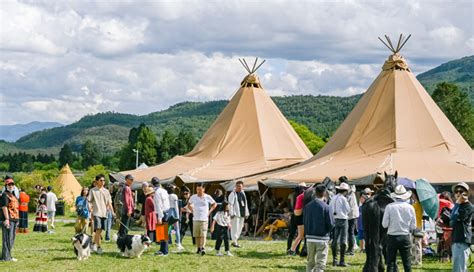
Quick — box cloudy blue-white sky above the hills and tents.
[0,0,474,125]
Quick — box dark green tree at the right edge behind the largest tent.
[432,82,474,148]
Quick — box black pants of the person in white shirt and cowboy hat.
[387,234,411,272]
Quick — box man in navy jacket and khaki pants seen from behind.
[303,184,334,272]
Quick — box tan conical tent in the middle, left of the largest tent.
[122,60,311,181]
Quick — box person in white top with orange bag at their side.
[152,178,170,256]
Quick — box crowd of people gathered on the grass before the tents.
[0,174,474,271]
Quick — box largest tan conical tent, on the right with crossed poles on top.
[248,35,474,184]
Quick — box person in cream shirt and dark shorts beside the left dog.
[88,174,112,254]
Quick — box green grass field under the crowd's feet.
[0,217,451,271]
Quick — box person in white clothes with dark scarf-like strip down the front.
[229,180,250,247]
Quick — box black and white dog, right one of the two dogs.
[113,234,151,258]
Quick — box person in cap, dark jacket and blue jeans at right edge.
[449,182,474,272]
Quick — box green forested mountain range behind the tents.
[0,56,474,154]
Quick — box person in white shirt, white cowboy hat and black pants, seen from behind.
[382,185,416,272]
